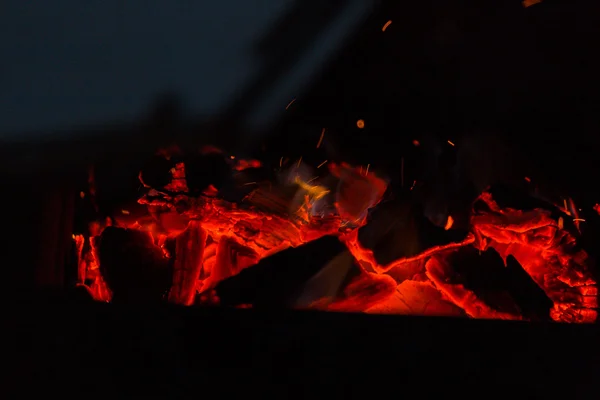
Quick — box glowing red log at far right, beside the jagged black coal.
[472,193,598,322]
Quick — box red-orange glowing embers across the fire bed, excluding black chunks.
[73,145,598,322]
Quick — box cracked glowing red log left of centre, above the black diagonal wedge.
[140,164,352,304]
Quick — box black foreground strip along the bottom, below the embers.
[3,304,600,398]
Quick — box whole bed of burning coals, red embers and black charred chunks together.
[73,147,598,322]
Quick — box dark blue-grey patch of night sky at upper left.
[0,0,298,135]
